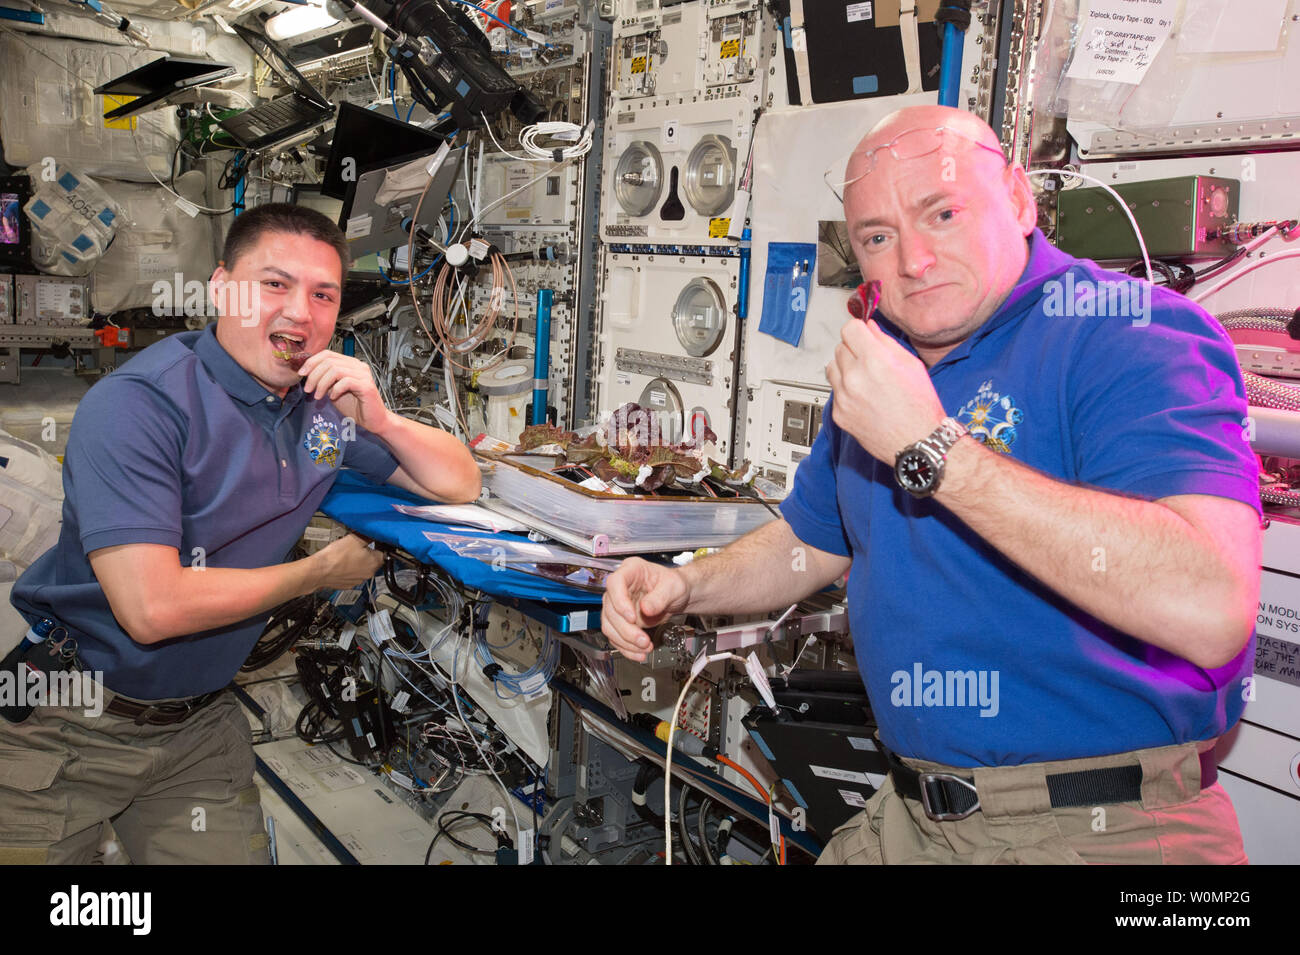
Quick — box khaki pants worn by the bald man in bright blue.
[818,742,1247,865]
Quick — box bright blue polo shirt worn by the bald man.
[781,231,1260,767]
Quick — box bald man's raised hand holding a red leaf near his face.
[826,318,944,466]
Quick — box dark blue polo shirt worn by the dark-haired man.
[10,325,398,700]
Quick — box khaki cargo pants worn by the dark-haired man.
[0,690,270,864]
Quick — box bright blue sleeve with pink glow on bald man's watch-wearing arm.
[1070,288,1260,511]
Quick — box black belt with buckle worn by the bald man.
[880,746,1218,822]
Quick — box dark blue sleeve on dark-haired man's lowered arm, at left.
[64,374,189,554]
